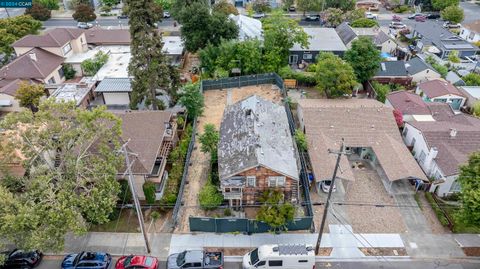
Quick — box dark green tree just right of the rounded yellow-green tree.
[344,36,382,83]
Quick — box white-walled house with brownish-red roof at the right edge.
[403,103,480,196]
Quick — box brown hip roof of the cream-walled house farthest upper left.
[12,28,83,47]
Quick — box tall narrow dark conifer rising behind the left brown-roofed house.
[126,0,179,110]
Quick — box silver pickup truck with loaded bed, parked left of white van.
[167,250,223,269]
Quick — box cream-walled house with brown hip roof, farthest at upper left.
[12,28,87,58]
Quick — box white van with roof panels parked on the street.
[242,244,315,269]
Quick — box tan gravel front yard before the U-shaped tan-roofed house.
[345,161,407,233]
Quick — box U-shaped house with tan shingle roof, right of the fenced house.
[297,99,427,193]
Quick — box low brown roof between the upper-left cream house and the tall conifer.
[83,27,131,46]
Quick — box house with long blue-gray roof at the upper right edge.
[412,21,479,59]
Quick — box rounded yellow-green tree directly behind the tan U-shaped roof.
[315,53,357,98]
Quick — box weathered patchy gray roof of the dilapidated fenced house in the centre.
[218,95,299,180]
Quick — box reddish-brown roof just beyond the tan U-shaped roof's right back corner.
[387,91,431,115]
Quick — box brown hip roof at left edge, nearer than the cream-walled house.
[0,48,63,80]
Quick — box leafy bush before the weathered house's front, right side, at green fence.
[257,190,295,231]
